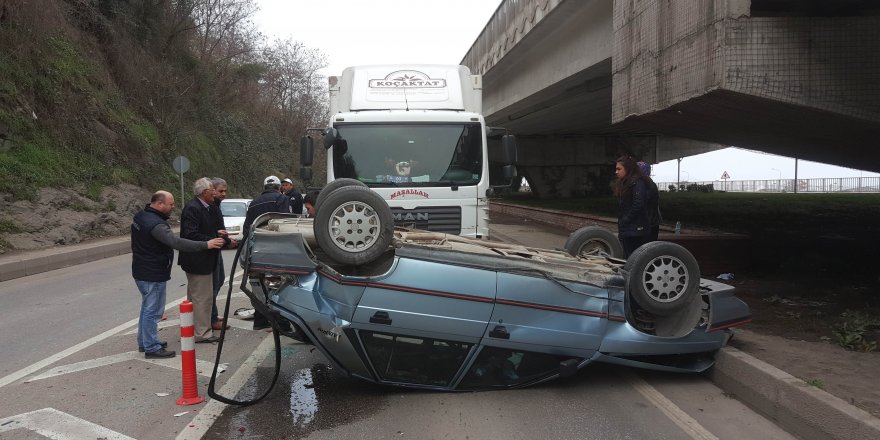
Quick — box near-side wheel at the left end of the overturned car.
[314,186,394,265]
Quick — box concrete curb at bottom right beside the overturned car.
[709,347,880,440]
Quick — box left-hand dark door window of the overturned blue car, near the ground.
[359,331,473,386]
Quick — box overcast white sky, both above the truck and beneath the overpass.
[255,0,880,182]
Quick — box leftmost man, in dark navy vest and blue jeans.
[131,191,223,358]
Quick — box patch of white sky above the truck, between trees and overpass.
[255,0,501,76]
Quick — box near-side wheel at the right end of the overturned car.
[623,241,700,316]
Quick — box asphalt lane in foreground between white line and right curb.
[205,345,794,439]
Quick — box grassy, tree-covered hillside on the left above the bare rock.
[0,0,326,201]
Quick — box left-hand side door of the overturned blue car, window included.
[351,257,496,388]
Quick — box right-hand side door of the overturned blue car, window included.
[457,272,608,389]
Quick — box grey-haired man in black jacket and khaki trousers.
[177,177,226,343]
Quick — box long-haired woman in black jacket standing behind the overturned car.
[613,156,651,258]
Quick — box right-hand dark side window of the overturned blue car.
[458,347,571,390]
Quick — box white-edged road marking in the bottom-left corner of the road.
[0,408,135,440]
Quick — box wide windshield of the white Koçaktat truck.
[333,123,483,186]
